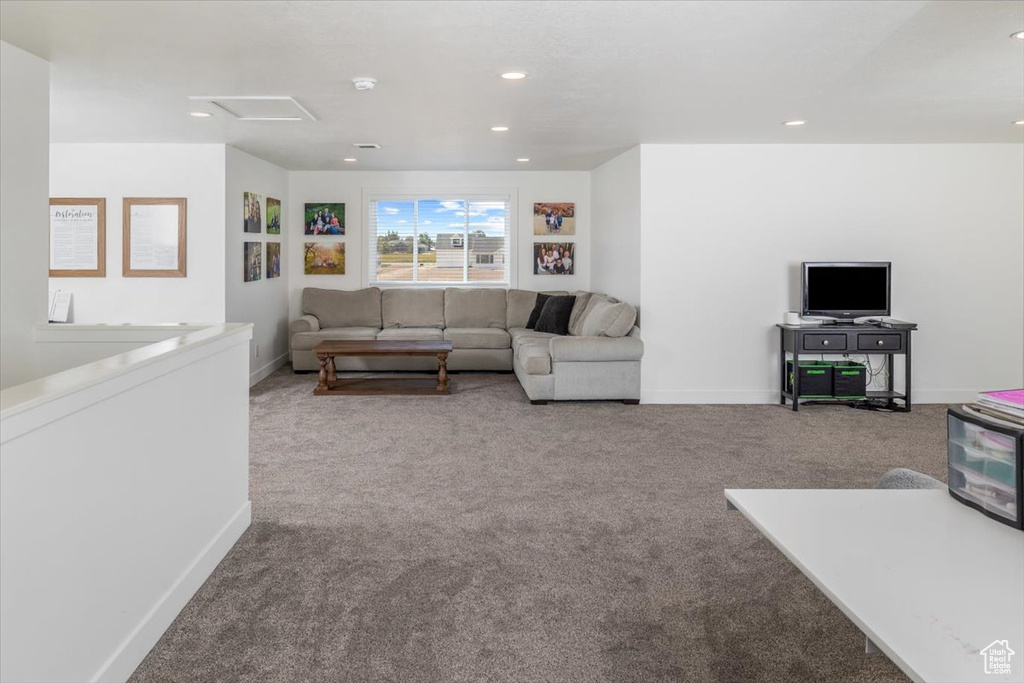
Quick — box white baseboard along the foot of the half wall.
[91,501,252,683]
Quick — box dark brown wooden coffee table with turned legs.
[313,339,452,396]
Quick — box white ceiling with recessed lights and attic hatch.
[0,0,1024,170]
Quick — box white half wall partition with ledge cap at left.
[0,324,252,683]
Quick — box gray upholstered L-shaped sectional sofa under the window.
[290,287,643,403]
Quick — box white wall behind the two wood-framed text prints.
[49,144,226,324]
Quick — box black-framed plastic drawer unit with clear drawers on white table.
[946,408,1024,528]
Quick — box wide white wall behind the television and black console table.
[640,144,1024,402]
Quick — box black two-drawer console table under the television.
[775,323,918,413]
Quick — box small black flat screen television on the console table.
[801,261,892,321]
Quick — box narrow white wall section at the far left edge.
[0,42,50,388]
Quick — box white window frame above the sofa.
[361,187,519,289]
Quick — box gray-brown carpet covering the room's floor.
[131,368,945,683]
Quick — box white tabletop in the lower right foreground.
[725,489,1024,683]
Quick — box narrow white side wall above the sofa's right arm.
[590,146,640,306]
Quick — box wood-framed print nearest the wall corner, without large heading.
[121,197,187,278]
